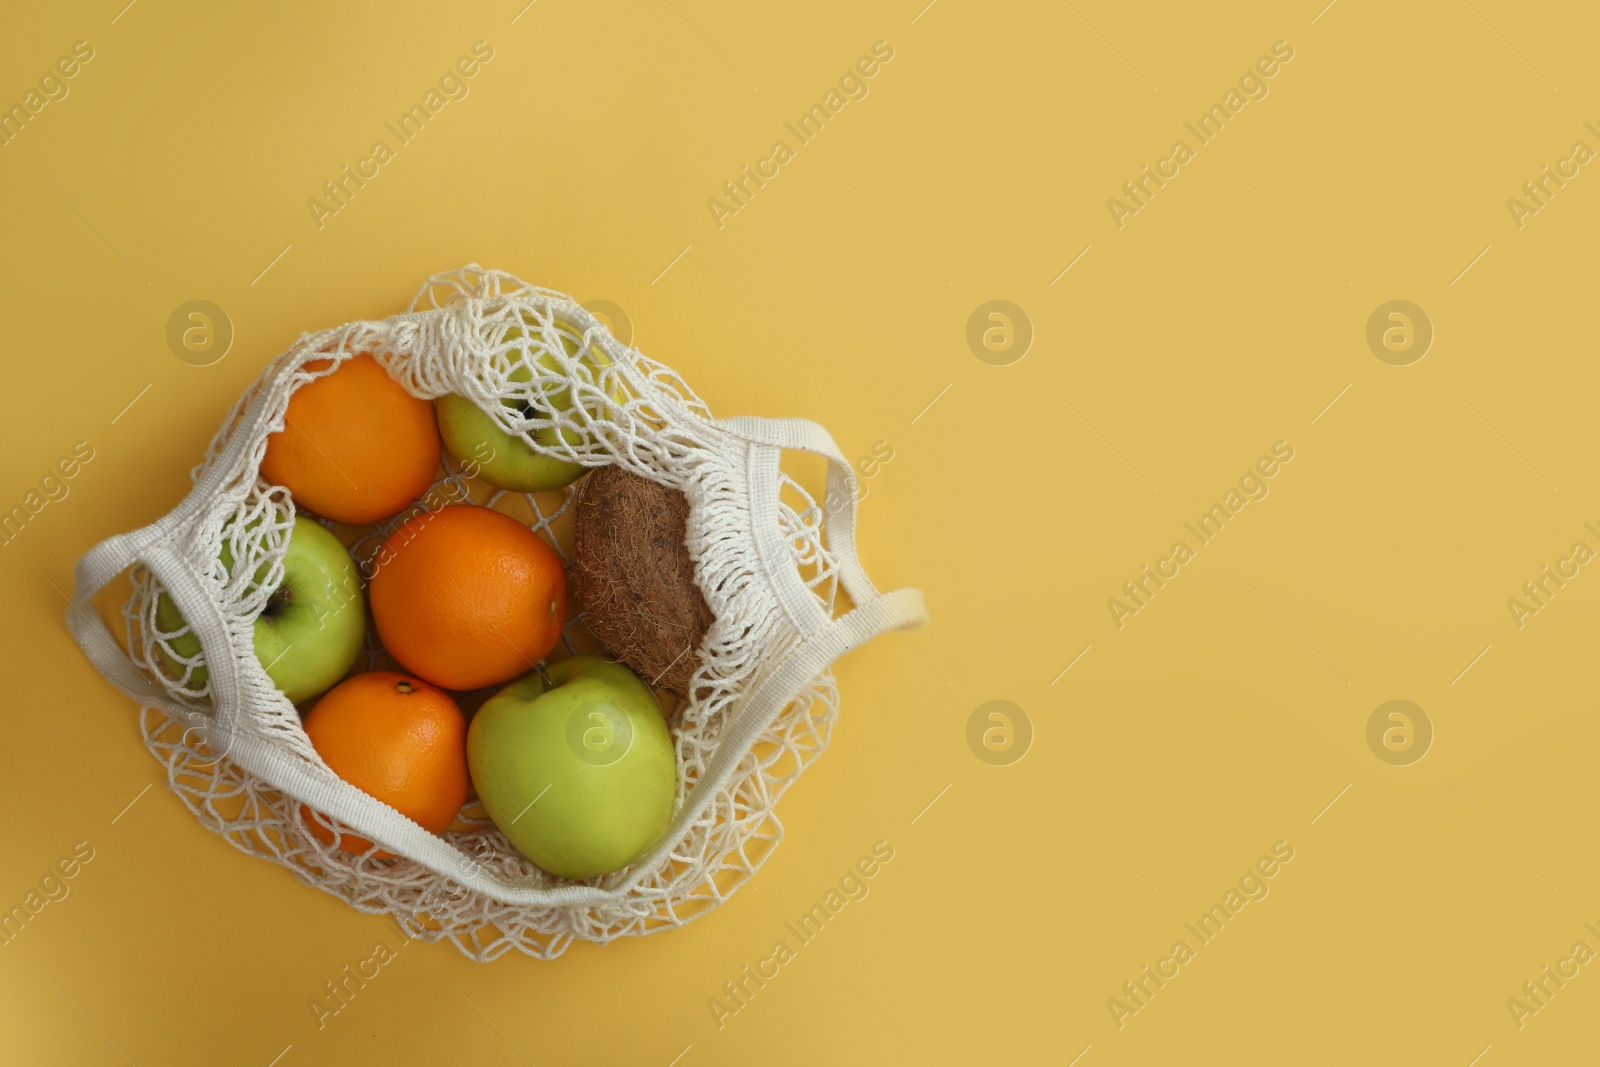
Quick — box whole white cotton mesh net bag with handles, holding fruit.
[67,266,926,960]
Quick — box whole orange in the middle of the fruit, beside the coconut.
[368,504,566,689]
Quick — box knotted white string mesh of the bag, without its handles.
[112,266,850,960]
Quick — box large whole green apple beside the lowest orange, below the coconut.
[467,656,677,878]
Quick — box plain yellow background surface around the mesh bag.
[0,0,1600,1067]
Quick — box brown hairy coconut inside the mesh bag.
[573,467,714,697]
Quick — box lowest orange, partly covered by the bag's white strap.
[301,670,472,859]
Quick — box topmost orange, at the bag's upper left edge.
[261,354,440,523]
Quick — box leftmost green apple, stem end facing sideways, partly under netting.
[155,515,366,704]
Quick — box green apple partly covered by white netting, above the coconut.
[434,310,610,493]
